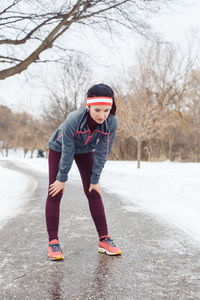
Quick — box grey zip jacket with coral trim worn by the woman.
[48,107,118,184]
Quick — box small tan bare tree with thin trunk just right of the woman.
[117,90,167,168]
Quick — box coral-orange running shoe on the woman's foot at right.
[98,235,122,255]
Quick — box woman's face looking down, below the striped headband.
[89,105,111,124]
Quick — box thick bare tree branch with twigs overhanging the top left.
[0,0,181,79]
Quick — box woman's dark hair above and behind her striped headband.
[87,83,117,115]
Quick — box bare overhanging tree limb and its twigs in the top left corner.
[0,0,177,79]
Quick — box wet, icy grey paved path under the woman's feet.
[0,161,200,300]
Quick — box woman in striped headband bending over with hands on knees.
[46,84,121,260]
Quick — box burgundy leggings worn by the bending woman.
[46,149,108,241]
